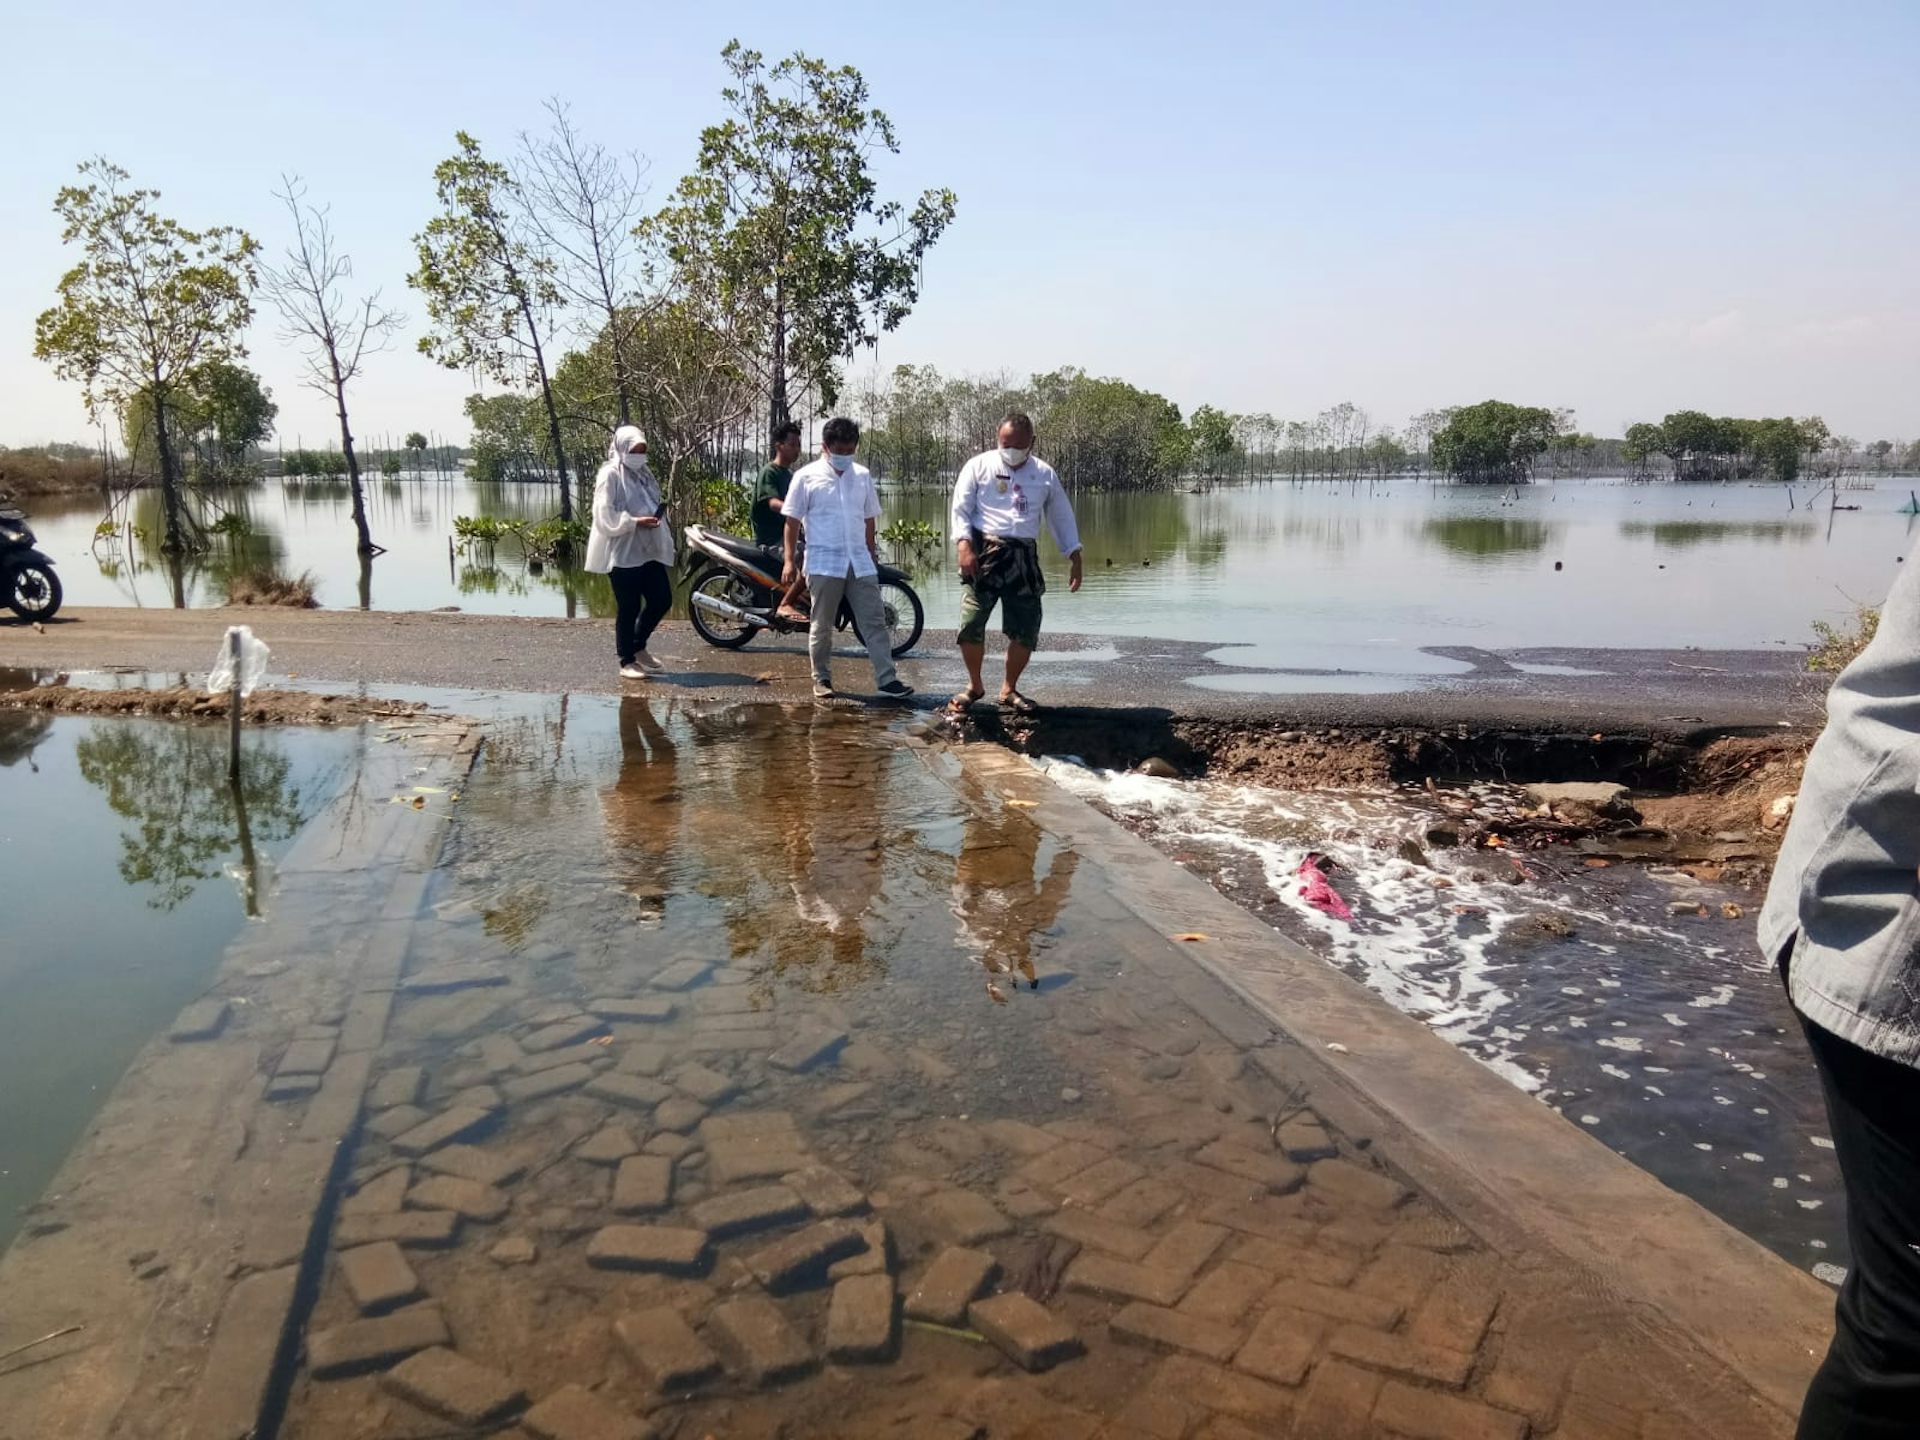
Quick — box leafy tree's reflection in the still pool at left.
[75,724,303,910]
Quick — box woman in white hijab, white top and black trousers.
[588,424,674,680]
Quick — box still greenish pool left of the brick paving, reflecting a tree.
[0,710,361,1250]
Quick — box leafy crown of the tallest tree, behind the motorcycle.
[643,40,954,424]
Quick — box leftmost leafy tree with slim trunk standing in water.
[33,157,259,555]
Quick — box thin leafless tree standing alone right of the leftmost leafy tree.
[265,177,405,555]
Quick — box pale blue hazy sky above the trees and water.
[0,0,1920,444]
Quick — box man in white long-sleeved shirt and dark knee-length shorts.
[950,411,1081,714]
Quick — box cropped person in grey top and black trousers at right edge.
[1761,563,1920,1440]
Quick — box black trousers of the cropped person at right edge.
[1799,1020,1920,1440]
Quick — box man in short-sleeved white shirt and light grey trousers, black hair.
[781,419,914,701]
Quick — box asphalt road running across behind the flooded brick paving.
[0,609,1818,732]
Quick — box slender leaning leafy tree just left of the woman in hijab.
[407,131,574,520]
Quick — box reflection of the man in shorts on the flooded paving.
[952,795,1079,1004]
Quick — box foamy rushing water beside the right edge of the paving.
[1041,760,1847,1271]
